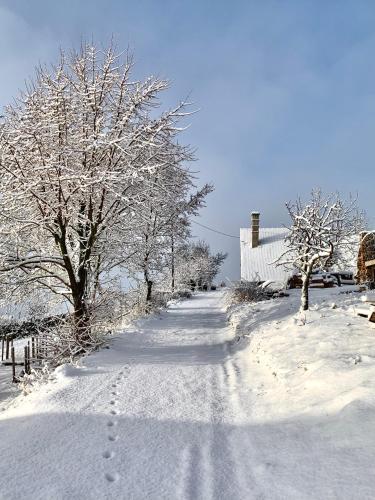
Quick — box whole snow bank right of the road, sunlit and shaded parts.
[225,289,375,499]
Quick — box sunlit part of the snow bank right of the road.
[230,289,375,420]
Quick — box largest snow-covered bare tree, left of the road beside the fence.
[0,45,197,337]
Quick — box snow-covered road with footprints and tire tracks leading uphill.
[0,292,257,499]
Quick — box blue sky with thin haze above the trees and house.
[0,0,375,278]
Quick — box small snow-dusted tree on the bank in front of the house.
[276,189,364,311]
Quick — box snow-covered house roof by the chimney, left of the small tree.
[240,227,290,281]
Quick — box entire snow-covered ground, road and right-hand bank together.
[0,289,375,500]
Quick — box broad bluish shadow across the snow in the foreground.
[0,402,375,500]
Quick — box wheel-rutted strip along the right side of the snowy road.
[178,300,261,500]
